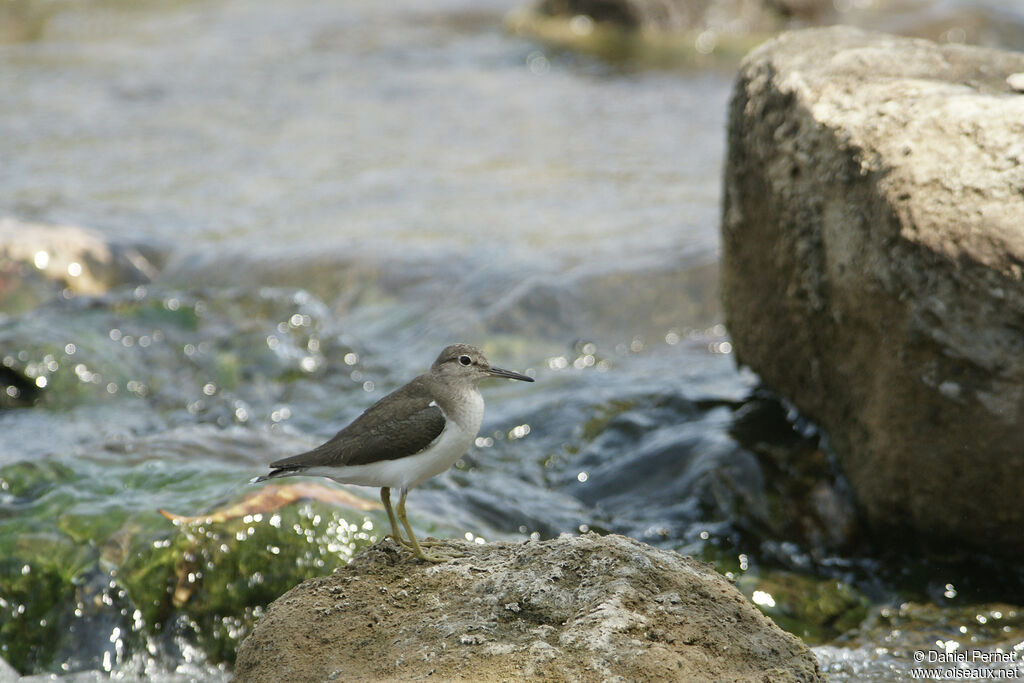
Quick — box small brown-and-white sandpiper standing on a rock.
[256,344,534,562]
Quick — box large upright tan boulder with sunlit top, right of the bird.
[722,28,1024,555]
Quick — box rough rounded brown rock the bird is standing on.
[236,535,823,682]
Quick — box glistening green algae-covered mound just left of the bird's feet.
[116,504,373,663]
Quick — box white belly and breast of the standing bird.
[303,391,483,488]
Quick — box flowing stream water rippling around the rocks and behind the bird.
[0,0,1022,680]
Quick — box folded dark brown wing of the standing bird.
[270,387,444,470]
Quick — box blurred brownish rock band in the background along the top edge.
[505,0,1024,66]
